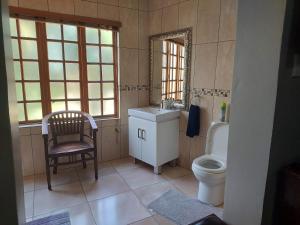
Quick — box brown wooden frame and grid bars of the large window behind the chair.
[10,7,121,124]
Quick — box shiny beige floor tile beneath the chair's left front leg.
[34,182,86,216]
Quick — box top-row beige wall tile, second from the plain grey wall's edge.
[197,0,220,44]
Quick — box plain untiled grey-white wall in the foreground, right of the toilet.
[224,0,285,225]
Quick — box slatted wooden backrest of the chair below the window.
[48,111,85,144]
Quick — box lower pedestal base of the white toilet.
[198,182,225,206]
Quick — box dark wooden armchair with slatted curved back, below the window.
[42,111,98,190]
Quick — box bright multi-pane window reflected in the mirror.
[162,41,185,100]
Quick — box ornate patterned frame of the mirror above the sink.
[149,28,192,110]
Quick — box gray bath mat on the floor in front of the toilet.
[148,190,223,225]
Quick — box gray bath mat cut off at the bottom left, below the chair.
[26,212,71,225]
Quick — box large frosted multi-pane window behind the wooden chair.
[10,18,118,123]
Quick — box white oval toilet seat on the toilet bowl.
[193,155,226,174]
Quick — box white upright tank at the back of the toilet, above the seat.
[205,122,229,163]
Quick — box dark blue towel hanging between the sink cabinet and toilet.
[186,105,200,137]
